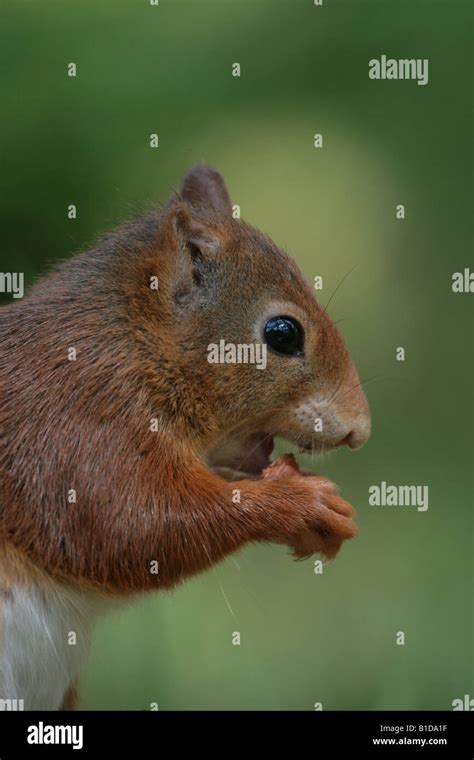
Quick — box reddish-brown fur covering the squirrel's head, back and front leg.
[0,169,367,594]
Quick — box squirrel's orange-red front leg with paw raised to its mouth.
[64,457,357,593]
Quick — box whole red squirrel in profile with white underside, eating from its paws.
[0,166,370,709]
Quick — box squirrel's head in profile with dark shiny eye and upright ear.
[127,166,370,473]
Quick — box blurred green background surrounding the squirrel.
[0,0,474,710]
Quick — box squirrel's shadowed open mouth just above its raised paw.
[206,432,274,480]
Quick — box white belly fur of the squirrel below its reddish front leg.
[0,583,104,710]
